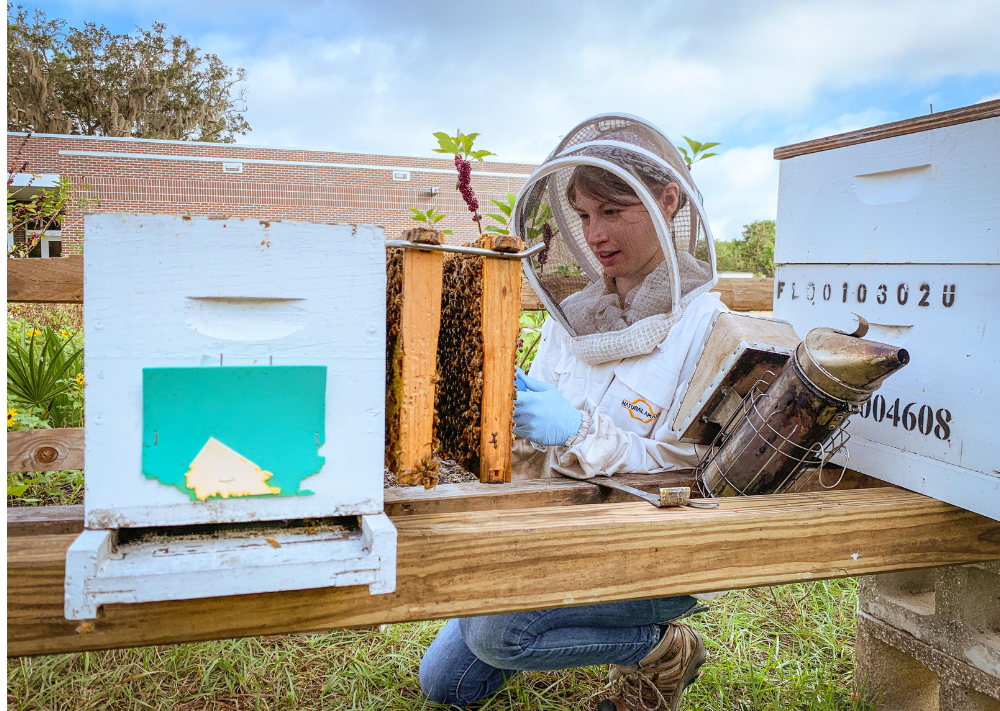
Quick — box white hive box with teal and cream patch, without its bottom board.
[84,214,385,529]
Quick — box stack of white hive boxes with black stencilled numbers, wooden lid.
[774,102,1000,519]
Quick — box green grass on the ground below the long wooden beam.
[7,580,873,711]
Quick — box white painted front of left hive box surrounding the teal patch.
[84,214,385,528]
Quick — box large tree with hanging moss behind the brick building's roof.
[7,5,250,143]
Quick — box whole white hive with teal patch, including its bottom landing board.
[66,214,395,619]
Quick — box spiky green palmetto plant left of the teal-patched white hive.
[7,326,83,424]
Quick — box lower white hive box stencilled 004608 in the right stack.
[774,265,1000,498]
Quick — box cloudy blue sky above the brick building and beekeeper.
[25,0,1000,239]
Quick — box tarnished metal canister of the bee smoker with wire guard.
[695,317,910,496]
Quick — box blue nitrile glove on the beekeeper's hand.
[514,368,583,446]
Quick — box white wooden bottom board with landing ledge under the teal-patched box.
[65,514,396,620]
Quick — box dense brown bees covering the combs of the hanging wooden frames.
[385,237,491,478]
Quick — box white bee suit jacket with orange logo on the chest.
[512,293,728,479]
